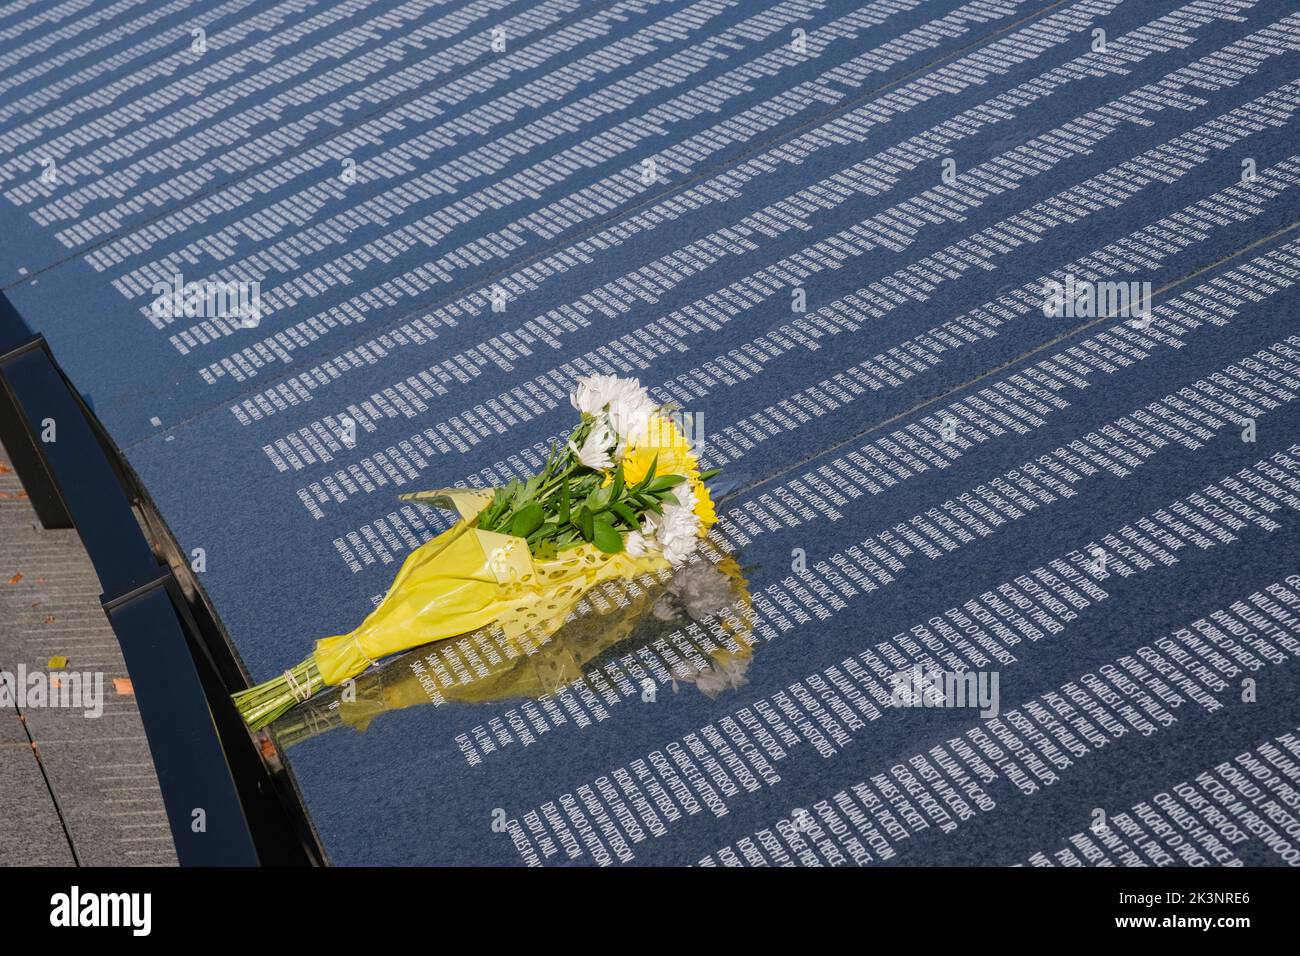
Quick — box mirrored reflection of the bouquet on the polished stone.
[274,541,753,747]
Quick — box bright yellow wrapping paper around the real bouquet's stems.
[315,488,668,684]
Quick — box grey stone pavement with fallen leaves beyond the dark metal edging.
[0,439,177,866]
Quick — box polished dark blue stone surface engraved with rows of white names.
[0,0,1300,864]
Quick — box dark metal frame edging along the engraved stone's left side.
[0,294,322,866]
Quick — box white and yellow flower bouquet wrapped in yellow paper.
[234,376,716,728]
